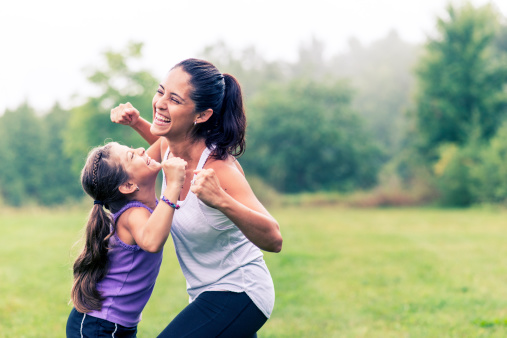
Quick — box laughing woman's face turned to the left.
[151,67,197,140]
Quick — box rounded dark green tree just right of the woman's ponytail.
[242,80,381,193]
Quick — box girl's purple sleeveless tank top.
[88,201,162,327]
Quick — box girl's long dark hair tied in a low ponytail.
[71,143,128,313]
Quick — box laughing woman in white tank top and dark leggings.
[111,59,282,337]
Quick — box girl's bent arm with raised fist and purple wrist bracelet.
[124,157,187,252]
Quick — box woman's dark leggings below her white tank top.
[158,291,268,338]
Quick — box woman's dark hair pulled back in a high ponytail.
[173,59,246,160]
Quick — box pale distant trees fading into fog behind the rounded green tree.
[202,35,417,160]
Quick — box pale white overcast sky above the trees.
[0,0,507,114]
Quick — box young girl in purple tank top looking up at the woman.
[67,142,187,337]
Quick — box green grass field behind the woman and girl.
[0,207,507,338]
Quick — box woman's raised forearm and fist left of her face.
[111,102,159,145]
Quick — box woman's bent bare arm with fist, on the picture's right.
[190,161,283,252]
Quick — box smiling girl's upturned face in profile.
[111,143,162,185]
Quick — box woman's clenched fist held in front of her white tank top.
[190,169,224,208]
